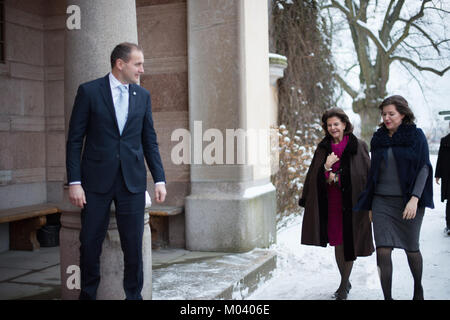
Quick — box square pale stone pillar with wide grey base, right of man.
[185,0,276,252]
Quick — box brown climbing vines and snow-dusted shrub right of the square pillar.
[270,0,336,217]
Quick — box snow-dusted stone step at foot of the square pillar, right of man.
[153,249,276,300]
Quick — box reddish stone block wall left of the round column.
[0,0,65,251]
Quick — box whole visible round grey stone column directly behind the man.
[60,0,151,299]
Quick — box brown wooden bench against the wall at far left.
[0,203,60,251]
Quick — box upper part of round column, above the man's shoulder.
[64,0,138,132]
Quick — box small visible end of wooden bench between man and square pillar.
[145,205,184,249]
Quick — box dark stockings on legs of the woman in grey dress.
[377,247,423,300]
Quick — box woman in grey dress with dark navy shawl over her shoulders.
[354,95,434,300]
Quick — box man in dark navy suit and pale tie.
[66,43,166,299]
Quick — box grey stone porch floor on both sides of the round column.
[0,247,276,300]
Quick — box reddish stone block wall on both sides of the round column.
[0,0,190,251]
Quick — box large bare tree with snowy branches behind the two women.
[321,0,450,141]
